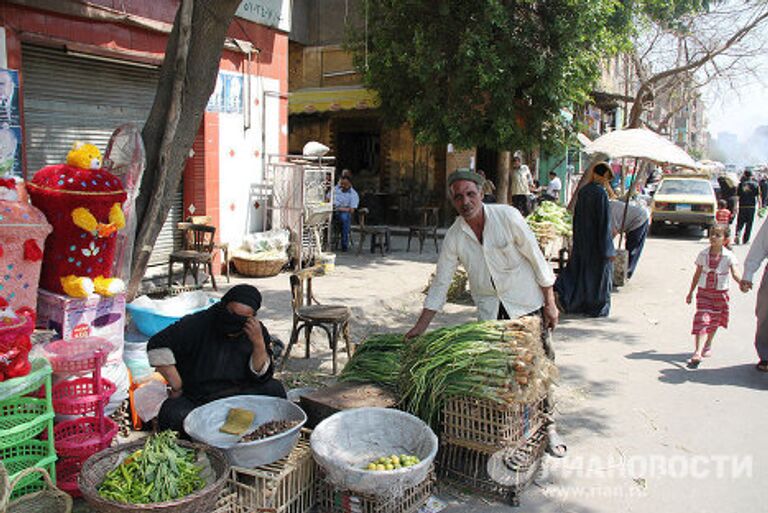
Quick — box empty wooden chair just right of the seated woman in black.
[280,266,352,375]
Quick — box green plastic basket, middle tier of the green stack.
[0,397,54,449]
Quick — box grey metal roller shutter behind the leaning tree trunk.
[22,45,183,265]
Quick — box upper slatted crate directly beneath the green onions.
[440,397,546,452]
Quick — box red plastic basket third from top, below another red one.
[53,417,118,460]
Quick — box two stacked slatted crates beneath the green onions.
[438,397,547,506]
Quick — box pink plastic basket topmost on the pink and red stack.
[43,337,112,374]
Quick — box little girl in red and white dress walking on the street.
[685,225,741,369]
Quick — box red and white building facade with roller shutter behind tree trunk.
[0,0,291,265]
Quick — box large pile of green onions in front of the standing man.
[341,318,557,427]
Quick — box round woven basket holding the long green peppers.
[78,440,229,513]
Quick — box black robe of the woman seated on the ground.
[147,303,274,404]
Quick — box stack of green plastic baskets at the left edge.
[0,358,56,499]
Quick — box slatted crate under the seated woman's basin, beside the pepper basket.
[214,429,317,513]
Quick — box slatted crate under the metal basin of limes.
[317,471,435,513]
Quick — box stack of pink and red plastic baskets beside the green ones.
[45,337,118,497]
